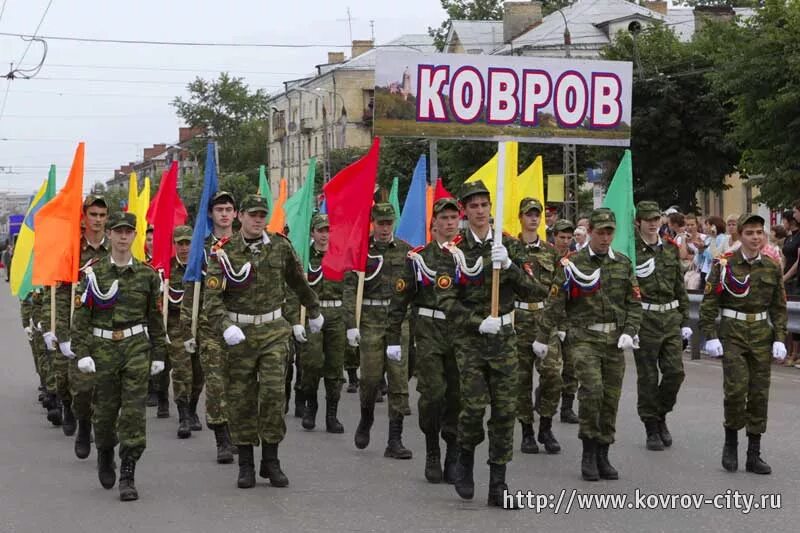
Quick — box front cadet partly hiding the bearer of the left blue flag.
[203,194,324,488]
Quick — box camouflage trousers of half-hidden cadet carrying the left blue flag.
[196,319,228,426]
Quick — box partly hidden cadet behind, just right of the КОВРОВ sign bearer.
[514,198,562,454]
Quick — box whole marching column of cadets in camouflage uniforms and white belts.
[21,186,787,507]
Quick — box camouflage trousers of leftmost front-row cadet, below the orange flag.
[92,334,150,461]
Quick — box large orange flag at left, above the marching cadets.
[33,143,85,285]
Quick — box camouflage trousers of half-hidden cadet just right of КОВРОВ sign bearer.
[514,309,562,424]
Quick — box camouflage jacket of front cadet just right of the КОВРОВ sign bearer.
[536,246,642,344]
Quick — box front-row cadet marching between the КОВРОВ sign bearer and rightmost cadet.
[537,209,642,481]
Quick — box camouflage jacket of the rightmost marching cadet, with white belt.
[700,249,788,342]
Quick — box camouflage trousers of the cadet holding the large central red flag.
[358,307,408,420]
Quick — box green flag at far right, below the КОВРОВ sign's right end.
[603,150,636,265]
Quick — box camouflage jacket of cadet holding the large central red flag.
[342,237,411,329]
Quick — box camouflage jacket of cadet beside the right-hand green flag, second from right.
[636,235,689,326]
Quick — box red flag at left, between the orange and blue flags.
[147,163,180,279]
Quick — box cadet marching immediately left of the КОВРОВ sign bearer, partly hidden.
[386,198,461,483]
